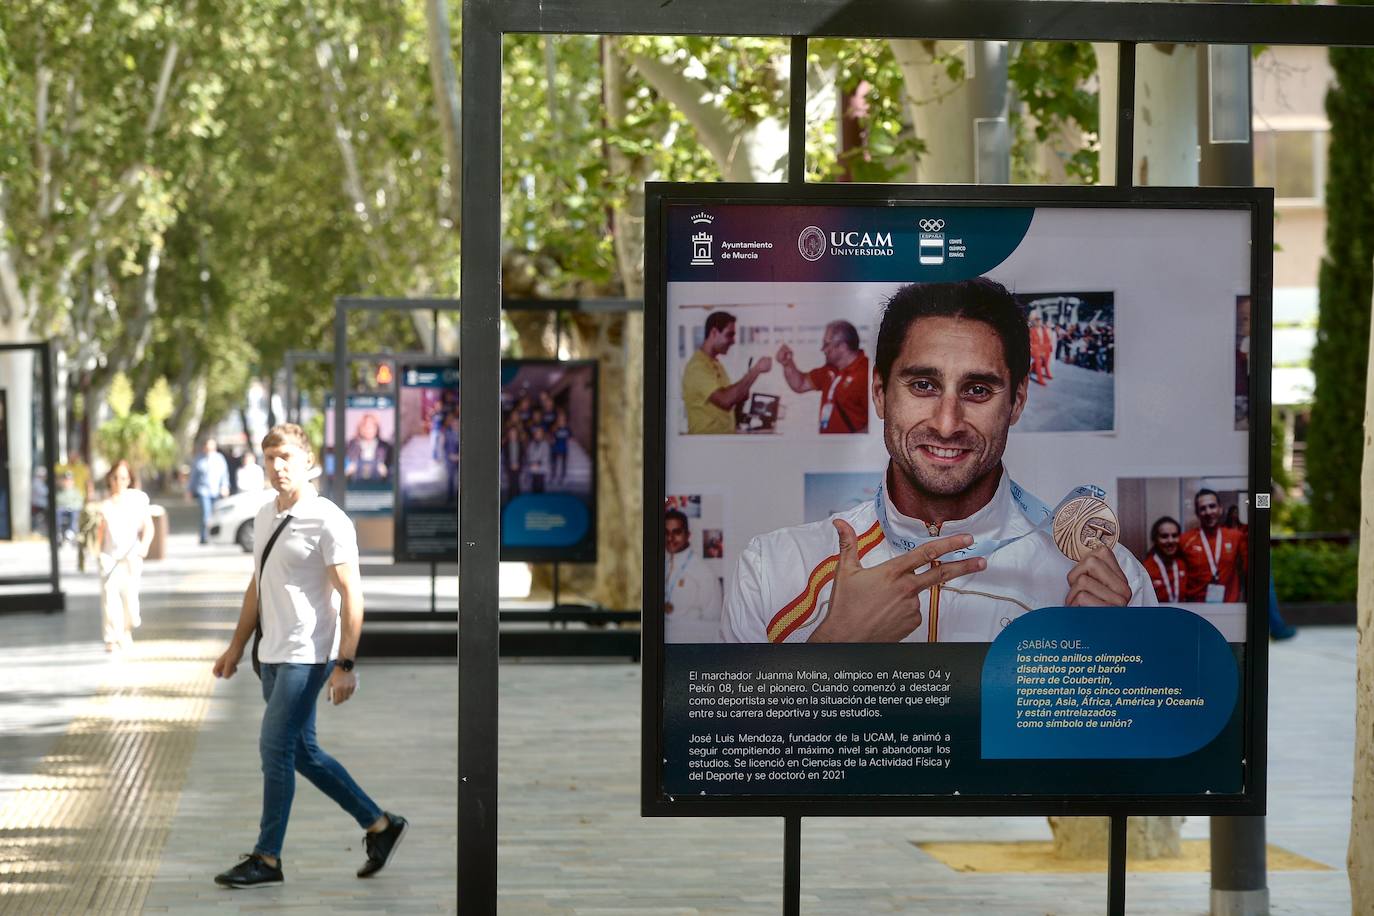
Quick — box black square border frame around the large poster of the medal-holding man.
[640,178,1274,817]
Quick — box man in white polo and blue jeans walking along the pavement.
[214,423,408,887]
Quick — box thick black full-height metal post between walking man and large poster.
[458,0,502,913]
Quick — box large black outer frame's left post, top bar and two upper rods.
[458,0,1374,912]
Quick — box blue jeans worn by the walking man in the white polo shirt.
[253,662,382,858]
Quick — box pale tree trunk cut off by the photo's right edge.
[1345,254,1374,913]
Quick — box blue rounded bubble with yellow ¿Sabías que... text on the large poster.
[982,607,1239,759]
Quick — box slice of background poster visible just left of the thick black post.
[394,363,460,563]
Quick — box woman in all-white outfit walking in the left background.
[98,459,153,652]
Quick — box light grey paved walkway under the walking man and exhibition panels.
[0,536,1355,916]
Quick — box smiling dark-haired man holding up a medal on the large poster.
[721,277,1156,643]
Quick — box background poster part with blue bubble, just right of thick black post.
[500,360,596,563]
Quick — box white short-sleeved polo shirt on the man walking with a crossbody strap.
[253,494,357,665]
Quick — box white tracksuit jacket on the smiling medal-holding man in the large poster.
[721,471,1156,643]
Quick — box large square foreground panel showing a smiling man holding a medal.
[642,184,1272,814]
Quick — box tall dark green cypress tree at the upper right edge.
[1307,35,1374,531]
